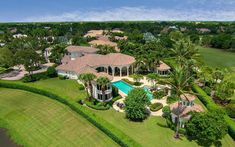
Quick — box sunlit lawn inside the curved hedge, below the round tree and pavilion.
[94,109,235,147]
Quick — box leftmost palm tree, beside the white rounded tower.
[78,73,96,101]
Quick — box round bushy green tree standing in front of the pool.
[124,88,150,121]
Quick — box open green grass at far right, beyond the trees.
[198,47,235,68]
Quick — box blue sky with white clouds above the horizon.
[0,0,235,22]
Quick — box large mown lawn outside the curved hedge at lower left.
[0,88,117,147]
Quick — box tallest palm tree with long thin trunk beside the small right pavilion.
[162,66,193,138]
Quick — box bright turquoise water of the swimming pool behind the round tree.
[112,80,153,100]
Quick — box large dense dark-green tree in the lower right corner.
[185,112,228,146]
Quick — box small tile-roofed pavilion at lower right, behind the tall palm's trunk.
[170,93,204,128]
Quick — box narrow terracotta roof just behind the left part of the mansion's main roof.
[66,45,99,53]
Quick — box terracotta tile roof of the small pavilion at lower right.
[170,102,204,117]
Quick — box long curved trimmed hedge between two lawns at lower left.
[0,81,140,146]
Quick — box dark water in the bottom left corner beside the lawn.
[0,128,20,147]
